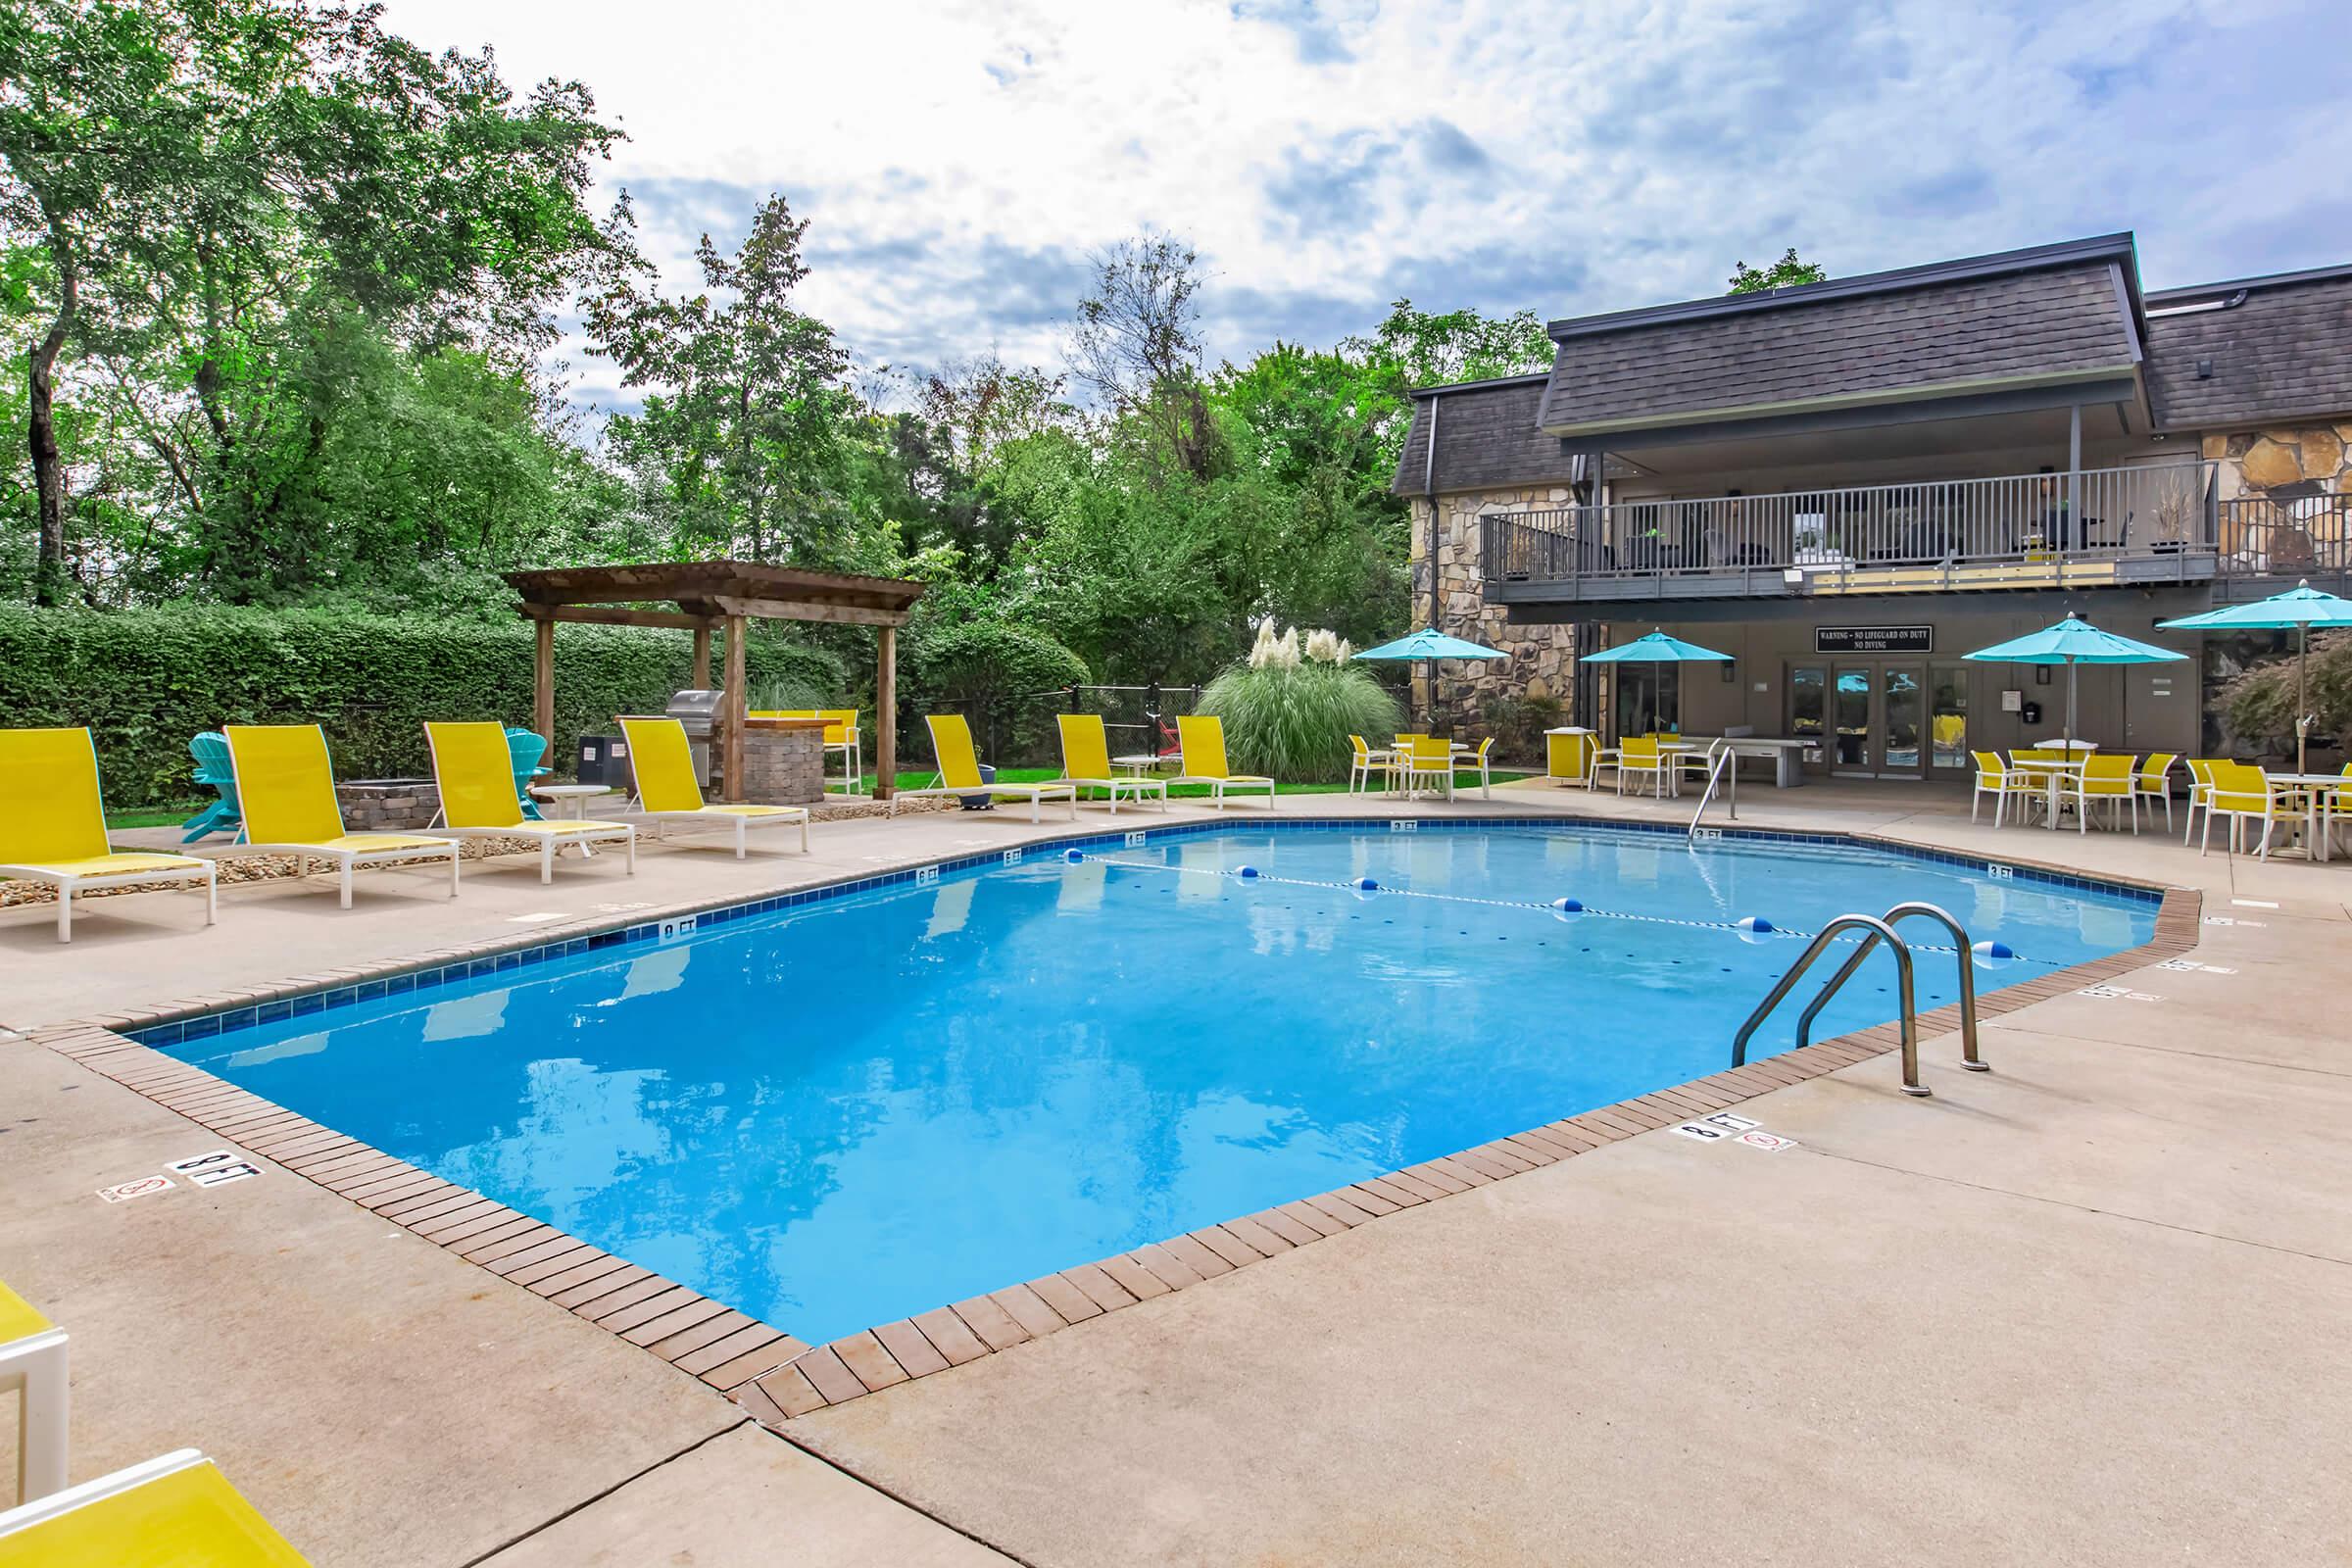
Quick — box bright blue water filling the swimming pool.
[167,823,2157,1343]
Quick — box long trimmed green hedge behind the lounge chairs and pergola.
[0,607,849,808]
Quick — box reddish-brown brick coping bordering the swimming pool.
[25,818,2204,1425]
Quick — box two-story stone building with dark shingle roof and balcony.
[1395,232,2352,778]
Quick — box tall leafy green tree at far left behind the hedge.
[0,0,618,600]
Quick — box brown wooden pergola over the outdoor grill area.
[506,562,922,802]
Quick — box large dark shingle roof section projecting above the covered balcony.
[1541,259,2135,435]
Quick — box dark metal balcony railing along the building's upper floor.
[1480,464,2220,597]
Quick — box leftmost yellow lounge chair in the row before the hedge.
[0,729,219,943]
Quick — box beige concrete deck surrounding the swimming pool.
[0,785,2352,1563]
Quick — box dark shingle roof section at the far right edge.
[2147,268,2352,430]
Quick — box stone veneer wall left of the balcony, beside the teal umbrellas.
[1411,484,1576,729]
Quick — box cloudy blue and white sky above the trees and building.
[388,0,2352,411]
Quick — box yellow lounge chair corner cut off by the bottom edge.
[0,1448,308,1568]
